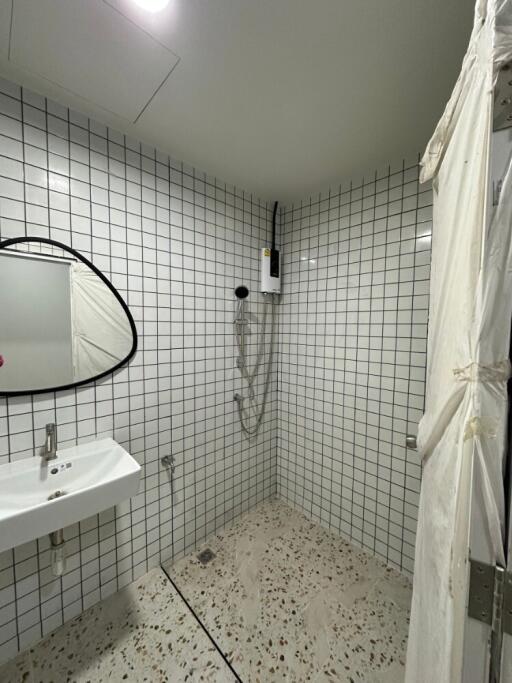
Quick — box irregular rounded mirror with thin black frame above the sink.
[0,237,137,396]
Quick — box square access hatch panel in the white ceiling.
[9,0,179,123]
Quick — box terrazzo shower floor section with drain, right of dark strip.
[164,500,411,683]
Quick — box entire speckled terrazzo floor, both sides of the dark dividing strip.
[0,500,411,683]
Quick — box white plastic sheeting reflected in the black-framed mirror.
[71,263,133,381]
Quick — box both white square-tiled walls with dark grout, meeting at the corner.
[0,69,431,661]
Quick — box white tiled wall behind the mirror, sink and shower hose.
[0,81,277,661]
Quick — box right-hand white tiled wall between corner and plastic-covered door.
[278,158,432,573]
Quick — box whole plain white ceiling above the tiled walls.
[0,0,473,202]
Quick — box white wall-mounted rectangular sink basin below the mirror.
[0,439,140,552]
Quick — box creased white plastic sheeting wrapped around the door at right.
[406,0,512,683]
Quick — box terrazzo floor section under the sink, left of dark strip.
[0,569,237,683]
